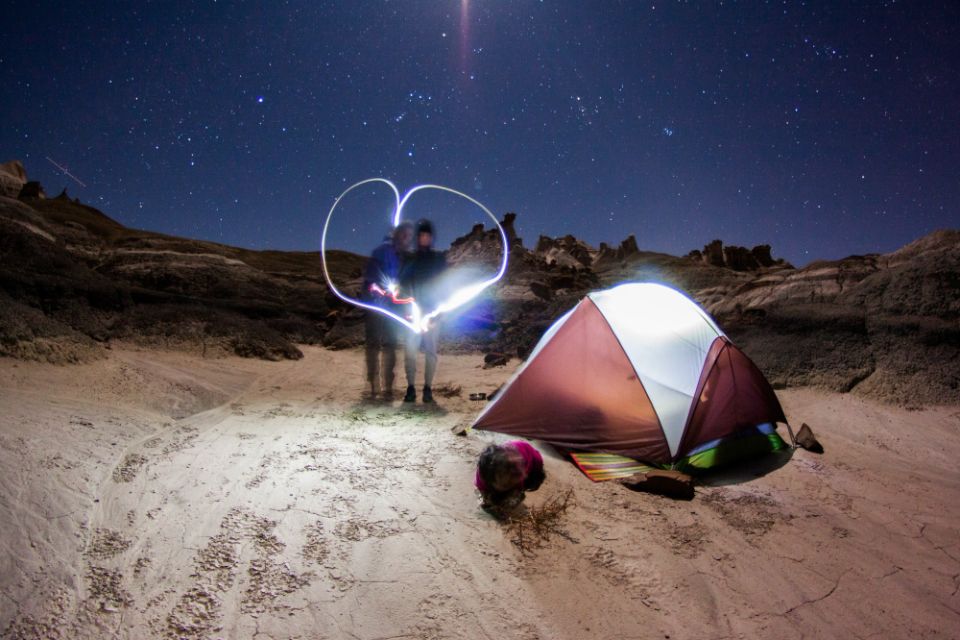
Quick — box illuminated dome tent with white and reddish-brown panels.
[473,283,786,471]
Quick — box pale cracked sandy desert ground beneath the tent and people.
[0,348,960,640]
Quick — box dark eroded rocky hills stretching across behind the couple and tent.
[0,170,960,404]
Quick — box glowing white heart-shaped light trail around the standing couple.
[320,178,510,333]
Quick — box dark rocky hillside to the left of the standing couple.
[0,190,362,362]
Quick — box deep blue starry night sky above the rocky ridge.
[0,0,960,266]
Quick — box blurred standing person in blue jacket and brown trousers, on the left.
[361,222,413,401]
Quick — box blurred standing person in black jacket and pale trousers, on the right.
[400,219,447,403]
